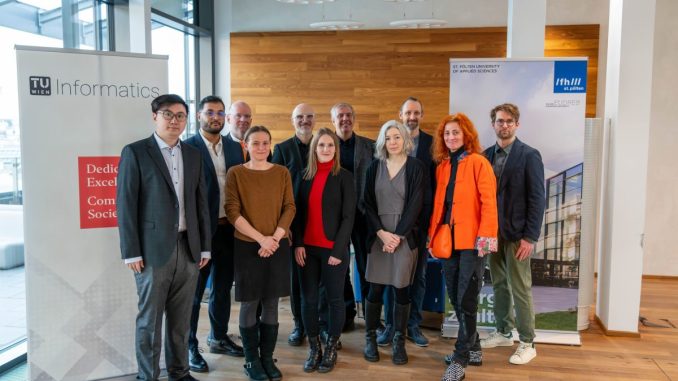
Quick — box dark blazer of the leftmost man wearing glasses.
[116,135,212,266]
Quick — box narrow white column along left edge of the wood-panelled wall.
[214,0,234,104]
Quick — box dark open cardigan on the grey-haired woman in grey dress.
[365,157,426,250]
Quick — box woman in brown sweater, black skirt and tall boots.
[225,126,296,381]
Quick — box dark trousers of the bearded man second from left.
[188,225,233,348]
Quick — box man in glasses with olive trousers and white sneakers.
[480,103,546,365]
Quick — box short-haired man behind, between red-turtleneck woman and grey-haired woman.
[330,103,374,331]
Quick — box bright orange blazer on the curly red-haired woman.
[428,153,499,250]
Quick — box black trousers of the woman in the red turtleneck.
[299,246,350,337]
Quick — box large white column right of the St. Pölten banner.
[596,0,655,334]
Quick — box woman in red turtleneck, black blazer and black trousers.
[293,128,356,373]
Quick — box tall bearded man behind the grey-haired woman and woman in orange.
[377,97,435,347]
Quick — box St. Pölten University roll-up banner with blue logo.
[443,58,591,344]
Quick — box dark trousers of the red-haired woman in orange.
[443,250,485,364]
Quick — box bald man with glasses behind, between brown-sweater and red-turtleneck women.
[272,103,315,346]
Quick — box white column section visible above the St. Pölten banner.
[506,0,546,58]
